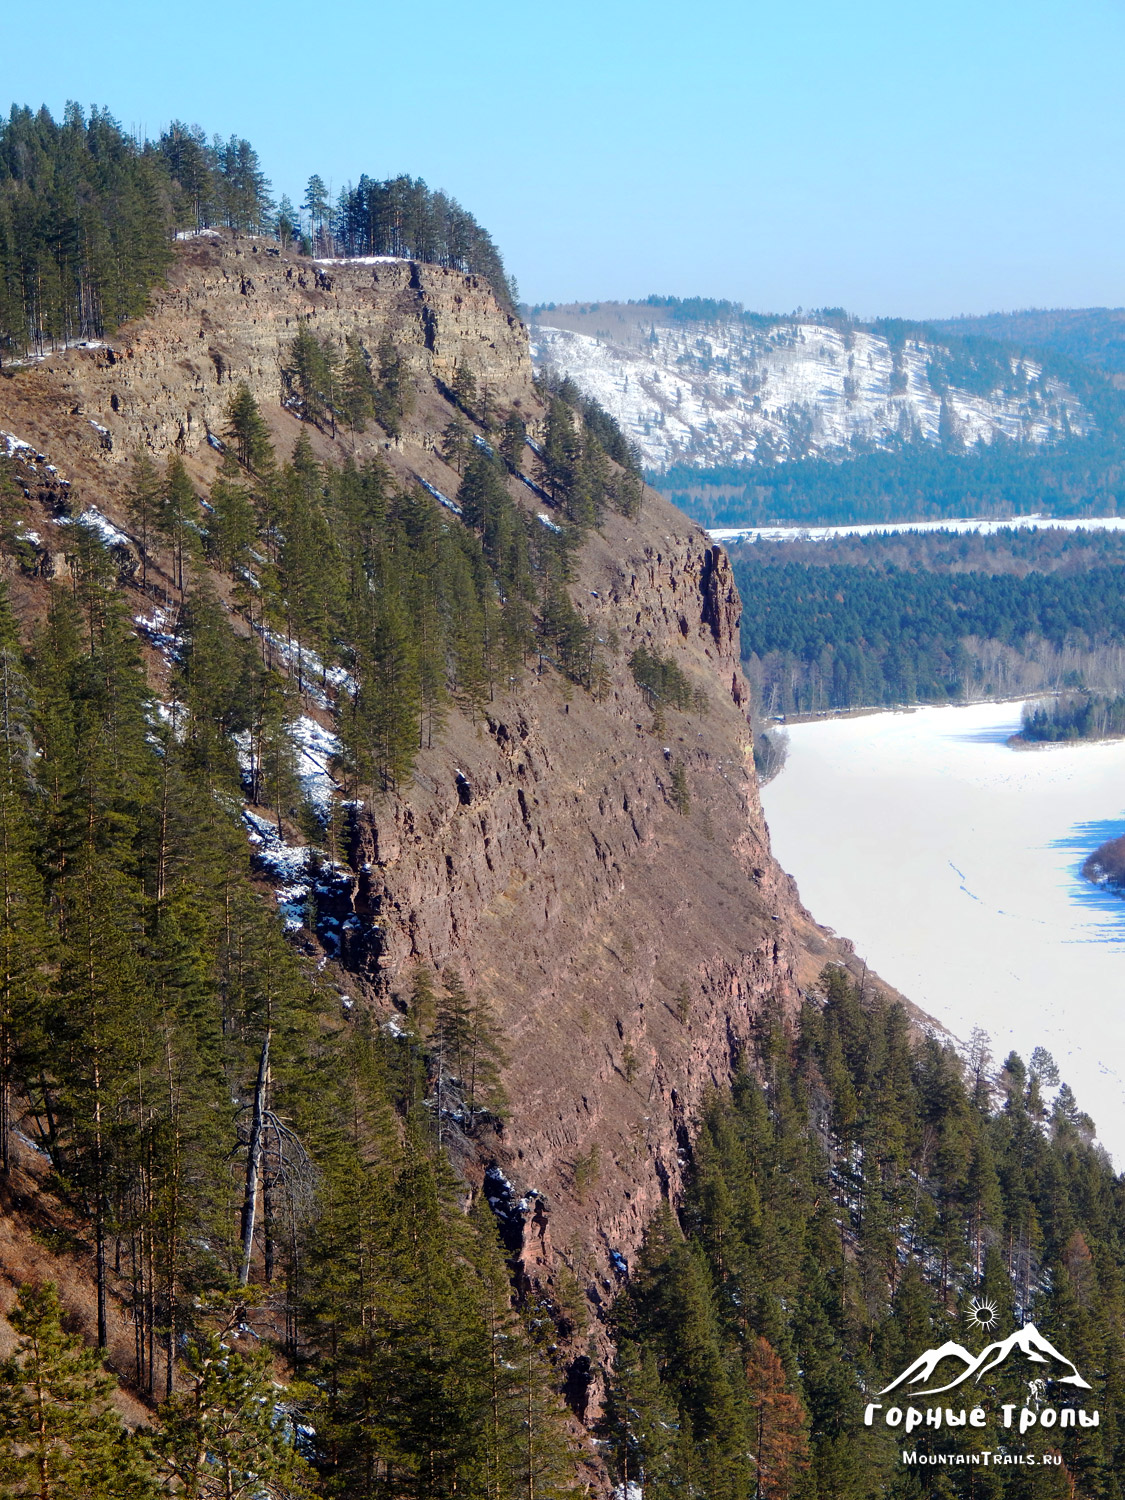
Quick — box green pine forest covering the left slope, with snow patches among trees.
[0,307,641,1500]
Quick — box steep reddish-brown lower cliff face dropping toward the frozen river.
[356,519,797,1293]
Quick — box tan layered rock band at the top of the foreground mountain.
[6,236,531,464]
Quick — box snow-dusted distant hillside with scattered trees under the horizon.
[533,318,1092,470]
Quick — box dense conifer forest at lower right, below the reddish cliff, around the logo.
[603,969,1125,1500]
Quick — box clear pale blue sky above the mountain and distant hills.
[0,0,1125,317]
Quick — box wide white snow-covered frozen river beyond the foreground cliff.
[762,704,1125,1167]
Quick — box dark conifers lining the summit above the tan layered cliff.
[0,104,512,357]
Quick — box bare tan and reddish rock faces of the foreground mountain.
[0,240,870,1407]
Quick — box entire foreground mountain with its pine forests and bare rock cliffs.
[0,99,1125,1500]
